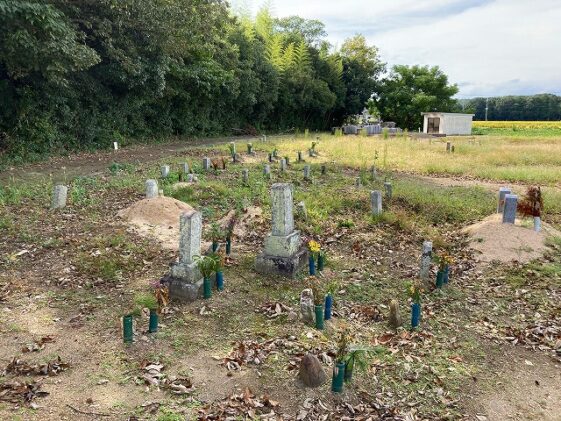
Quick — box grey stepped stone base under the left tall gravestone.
[162,263,203,303]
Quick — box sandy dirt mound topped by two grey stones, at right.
[463,214,561,263]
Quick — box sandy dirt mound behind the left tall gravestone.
[117,197,194,250]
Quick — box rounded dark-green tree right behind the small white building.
[374,65,458,129]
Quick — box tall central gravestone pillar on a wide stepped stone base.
[255,183,308,277]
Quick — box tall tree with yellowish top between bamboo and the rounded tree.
[339,35,385,119]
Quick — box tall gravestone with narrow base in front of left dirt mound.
[167,210,203,302]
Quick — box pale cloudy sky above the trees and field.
[232,0,561,98]
